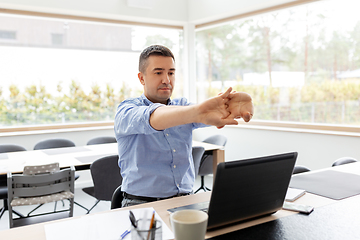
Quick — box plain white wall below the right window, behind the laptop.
[193,126,360,170]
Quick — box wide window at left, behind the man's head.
[0,14,183,127]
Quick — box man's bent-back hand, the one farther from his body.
[227,92,254,122]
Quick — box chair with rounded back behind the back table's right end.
[195,135,227,193]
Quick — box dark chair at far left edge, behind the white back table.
[0,144,26,218]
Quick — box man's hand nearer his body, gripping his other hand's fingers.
[198,87,238,128]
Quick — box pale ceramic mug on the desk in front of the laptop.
[170,210,208,240]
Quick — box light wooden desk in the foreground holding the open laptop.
[0,162,360,240]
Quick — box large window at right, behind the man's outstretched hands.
[196,0,360,125]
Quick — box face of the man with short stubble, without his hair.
[138,56,175,104]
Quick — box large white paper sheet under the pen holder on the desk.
[44,208,174,240]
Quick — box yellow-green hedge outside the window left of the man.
[0,81,134,126]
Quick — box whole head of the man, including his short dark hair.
[138,45,175,104]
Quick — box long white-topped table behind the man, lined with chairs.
[0,141,225,175]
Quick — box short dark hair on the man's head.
[139,45,175,73]
